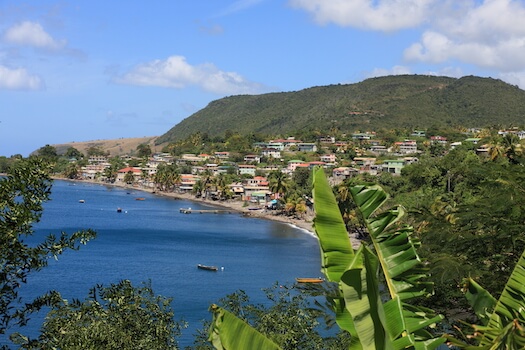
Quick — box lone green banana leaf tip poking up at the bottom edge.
[208,305,281,350]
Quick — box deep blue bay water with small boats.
[4,181,321,347]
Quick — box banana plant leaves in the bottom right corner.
[447,252,525,349]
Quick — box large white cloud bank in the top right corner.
[405,0,525,72]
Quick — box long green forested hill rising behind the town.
[157,75,525,143]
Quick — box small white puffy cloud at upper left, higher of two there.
[4,21,66,50]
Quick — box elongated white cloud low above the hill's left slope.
[115,56,263,95]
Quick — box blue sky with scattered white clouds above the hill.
[0,0,525,157]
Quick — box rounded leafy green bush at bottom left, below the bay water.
[12,280,185,350]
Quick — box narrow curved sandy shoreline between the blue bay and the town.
[61,177,317,235]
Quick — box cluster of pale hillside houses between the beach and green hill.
[81,130,525,200]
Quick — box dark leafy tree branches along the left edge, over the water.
[0,157,95,340]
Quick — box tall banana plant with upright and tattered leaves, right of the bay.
[314,169,445,349]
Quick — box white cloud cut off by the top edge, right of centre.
[289,0,437,31]
